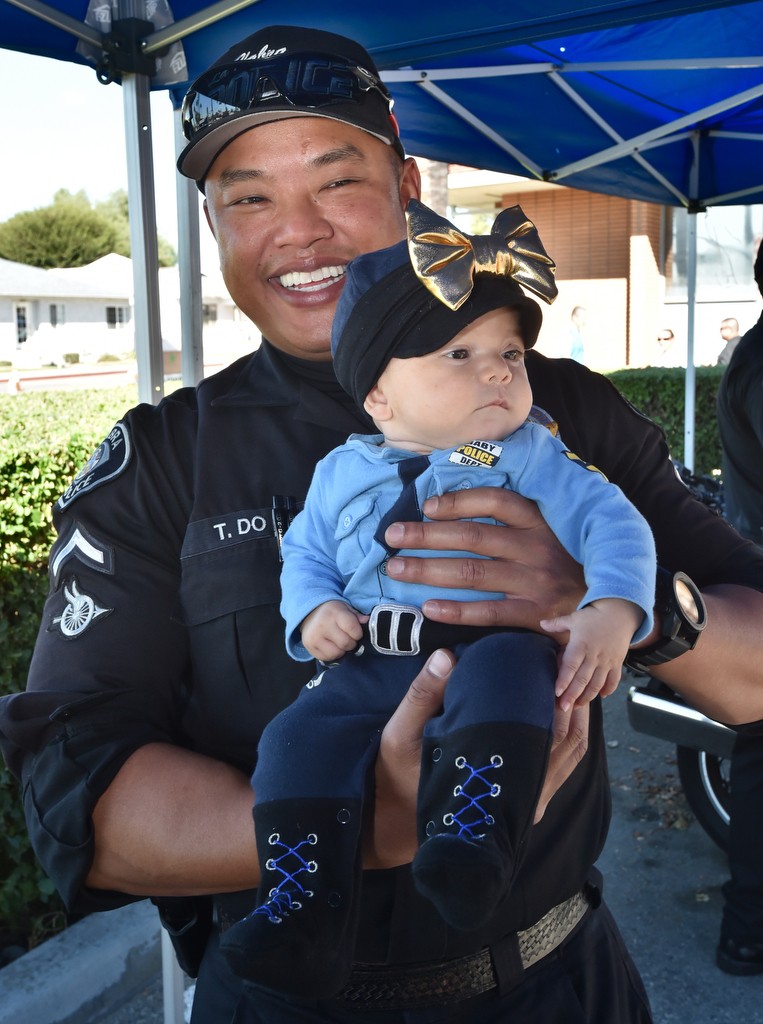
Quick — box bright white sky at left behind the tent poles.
[0,49,196,254]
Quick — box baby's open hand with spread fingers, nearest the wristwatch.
[541,598,643,711]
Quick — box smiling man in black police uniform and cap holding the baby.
[0,28,763,1024]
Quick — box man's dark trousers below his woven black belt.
[190,903,652,1024]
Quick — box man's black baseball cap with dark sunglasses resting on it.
[177,25,405,183]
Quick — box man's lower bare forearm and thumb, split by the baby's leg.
[87,651,455,896]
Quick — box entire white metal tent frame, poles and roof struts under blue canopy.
[6,0,763,448]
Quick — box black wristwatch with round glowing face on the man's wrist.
[625,566,708,672]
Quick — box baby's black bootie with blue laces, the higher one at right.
[413,722,551,930]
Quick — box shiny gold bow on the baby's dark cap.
[406,199,557,309]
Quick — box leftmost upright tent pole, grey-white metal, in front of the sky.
[122,74,164,406]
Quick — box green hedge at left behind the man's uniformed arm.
[0,387,136,944]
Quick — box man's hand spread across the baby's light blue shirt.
[385,487,586,632]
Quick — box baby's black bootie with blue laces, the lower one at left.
[220,800,361,999]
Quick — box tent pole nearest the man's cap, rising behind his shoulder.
[174,110,204,386]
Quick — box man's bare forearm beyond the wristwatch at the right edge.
[647,584,763,725]
